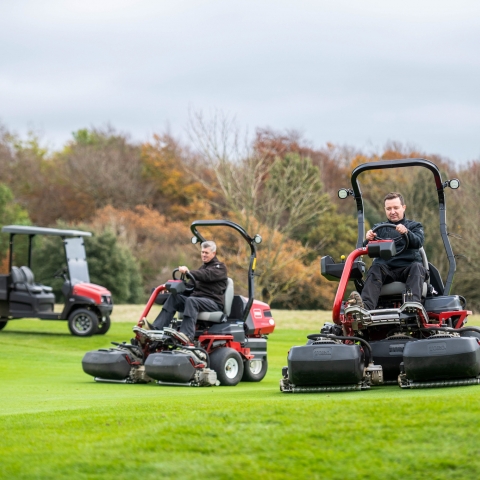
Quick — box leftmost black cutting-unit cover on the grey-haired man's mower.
[82,349,134,380]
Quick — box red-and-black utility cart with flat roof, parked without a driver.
[0,225,113,337]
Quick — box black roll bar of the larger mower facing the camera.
[350,158,456,295]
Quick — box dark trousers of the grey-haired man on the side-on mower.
[153,295,223,341]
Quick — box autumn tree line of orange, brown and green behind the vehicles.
[0,118,480,310]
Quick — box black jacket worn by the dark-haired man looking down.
[363,218,425,268]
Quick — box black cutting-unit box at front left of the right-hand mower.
[288,342,365,386]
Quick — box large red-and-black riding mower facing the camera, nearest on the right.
[280,159,480,393]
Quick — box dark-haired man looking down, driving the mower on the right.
[347,192,427,310]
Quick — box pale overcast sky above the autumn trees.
[0,0,480,162]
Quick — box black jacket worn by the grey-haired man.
[190,256,228,310]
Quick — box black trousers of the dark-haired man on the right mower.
[362,262,427,310]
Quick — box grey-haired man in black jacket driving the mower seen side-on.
[153,241,228,344]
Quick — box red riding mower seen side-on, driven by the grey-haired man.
[82,220,275,386]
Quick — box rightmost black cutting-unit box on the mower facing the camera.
[403,336,480,381]
